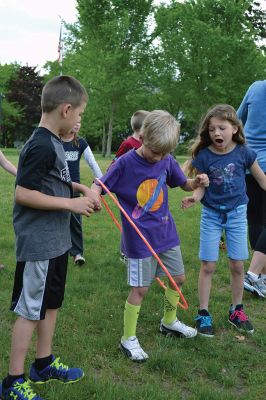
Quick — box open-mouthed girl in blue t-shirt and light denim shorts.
[182,105,266,336]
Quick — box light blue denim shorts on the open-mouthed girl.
[199,204,248,261]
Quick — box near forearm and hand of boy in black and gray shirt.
[15,185,99,217]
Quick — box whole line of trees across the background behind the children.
[0,0,266,156]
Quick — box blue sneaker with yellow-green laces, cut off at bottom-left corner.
[0,378,44,400]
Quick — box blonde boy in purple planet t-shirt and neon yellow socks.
[93,110,209,362]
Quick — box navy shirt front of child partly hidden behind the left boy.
[62,137,88,183]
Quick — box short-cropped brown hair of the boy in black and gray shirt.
[41,75,88,113]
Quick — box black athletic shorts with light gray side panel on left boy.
[11,252,68,321]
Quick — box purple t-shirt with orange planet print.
[101,150,187,258]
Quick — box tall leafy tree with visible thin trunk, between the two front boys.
[63,0,152,156]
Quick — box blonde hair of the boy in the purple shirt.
[141,110,180,154]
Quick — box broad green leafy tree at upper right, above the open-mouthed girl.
[155,0,265,138]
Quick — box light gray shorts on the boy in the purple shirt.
[127,246,185,287]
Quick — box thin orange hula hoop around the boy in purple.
[95,178,188,310]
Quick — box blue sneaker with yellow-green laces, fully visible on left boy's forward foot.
[29,356,84,384]
